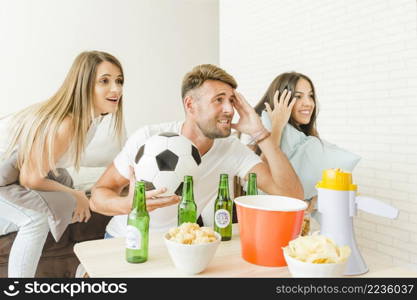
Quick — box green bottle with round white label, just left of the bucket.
[214,174,233,241]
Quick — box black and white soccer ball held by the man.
[134,132,201,196]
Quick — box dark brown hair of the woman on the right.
[255,72,319,137]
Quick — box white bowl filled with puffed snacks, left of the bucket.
[164,223,221,275]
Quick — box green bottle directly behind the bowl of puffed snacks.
[178,175,197,226]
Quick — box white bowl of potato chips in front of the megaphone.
[283,235,351,277]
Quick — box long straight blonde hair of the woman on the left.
[6,51,123,176]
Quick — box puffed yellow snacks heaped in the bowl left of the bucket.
[168,223,217,245]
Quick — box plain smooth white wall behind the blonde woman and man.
[0,0,218,133]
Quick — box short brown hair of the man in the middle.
[181,64,237,99]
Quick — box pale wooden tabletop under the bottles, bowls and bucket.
[74,224,417,278]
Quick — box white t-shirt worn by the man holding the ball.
[106,122,262,236]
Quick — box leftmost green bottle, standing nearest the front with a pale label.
[126,181,149,263]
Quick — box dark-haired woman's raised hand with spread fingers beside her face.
[265,89,296,136]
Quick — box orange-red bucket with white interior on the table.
[234,195,307,267]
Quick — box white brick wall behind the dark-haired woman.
[220,0,417,268]
